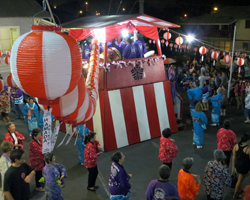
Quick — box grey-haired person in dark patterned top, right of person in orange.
[203,149,231,200]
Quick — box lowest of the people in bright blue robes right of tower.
[192,103,207,149]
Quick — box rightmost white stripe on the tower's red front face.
[154,82,170,131]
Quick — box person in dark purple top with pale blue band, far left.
[11,86,23,119]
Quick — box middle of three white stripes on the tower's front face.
[132,86,151,141]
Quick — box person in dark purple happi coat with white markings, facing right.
[109,152,132,200]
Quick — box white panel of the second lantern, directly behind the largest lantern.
[59,85,80,117]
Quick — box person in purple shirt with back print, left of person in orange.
[145,165,180,200]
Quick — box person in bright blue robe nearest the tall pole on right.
[210,88,223,126]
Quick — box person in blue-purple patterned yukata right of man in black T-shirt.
[43,153,67,200]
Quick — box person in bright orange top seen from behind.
[178,157,201,200]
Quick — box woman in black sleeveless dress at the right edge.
[232,133,250,199]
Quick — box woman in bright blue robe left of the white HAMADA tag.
[22,97,39,136]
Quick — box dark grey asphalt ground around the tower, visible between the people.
[0,91,250,200]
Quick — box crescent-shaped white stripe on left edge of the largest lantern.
[10,31,31,93]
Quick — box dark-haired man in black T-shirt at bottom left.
[4,149,36,200]
